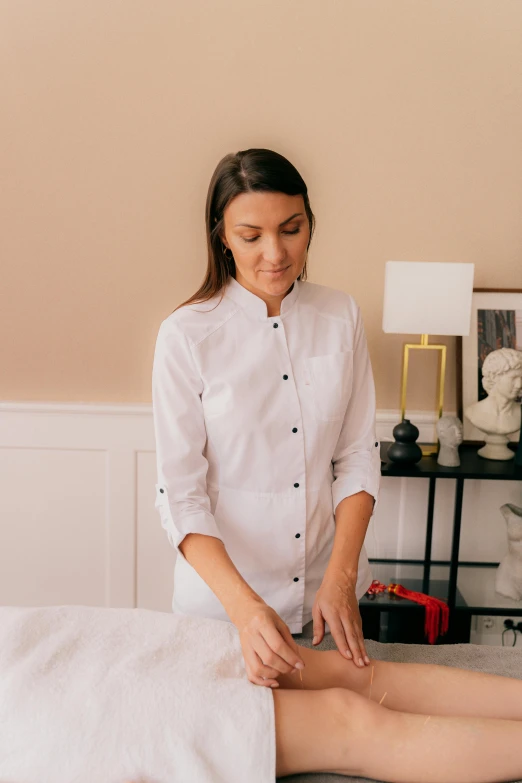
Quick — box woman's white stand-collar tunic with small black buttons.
[152,278,380,633]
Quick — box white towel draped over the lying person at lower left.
[0,606,275,783]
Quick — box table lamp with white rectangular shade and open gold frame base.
[382,261,475,455]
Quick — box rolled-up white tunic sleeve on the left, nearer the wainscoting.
[152,320,223,551]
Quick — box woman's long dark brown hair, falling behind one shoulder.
[173,149,315,312]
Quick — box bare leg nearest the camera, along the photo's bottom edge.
[273,688,522,783]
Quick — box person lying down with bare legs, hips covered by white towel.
[0,606,522,783]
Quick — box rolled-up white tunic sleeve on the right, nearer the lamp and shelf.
[332,299,381,514]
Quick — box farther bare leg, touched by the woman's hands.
[278,647,522,720]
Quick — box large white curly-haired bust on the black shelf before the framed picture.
[464,348,522,459]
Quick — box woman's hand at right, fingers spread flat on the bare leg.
[312,574,370,667]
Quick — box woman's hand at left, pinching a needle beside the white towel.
[233,601,304,688]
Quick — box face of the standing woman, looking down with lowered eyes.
[221,192,310,304]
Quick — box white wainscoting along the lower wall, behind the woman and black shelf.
[0,402,522,612]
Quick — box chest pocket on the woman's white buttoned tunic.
[305,351,353,421]
